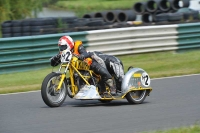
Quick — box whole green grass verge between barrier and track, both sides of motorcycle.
[0,51,200,94]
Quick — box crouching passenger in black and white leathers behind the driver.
[88,51,124,90]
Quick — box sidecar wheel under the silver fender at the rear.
[126,90,148,104]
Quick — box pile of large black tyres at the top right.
[133,0,199,23]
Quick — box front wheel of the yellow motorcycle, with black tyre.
[41,72,67,107]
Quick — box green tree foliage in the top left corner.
[0,0,51,23]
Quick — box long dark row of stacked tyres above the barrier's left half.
[1,17,104,38]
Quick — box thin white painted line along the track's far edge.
[0,74,200,96]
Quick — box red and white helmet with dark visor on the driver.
[58,36,74,51]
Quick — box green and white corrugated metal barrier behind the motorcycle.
[0,23,200,74]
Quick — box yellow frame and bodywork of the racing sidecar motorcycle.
[56,56,152,100]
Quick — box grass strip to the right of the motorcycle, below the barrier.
[120,51,200,78]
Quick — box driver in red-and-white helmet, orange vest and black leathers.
[51,36,116,95]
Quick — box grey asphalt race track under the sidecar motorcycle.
[0,75,200,133]
